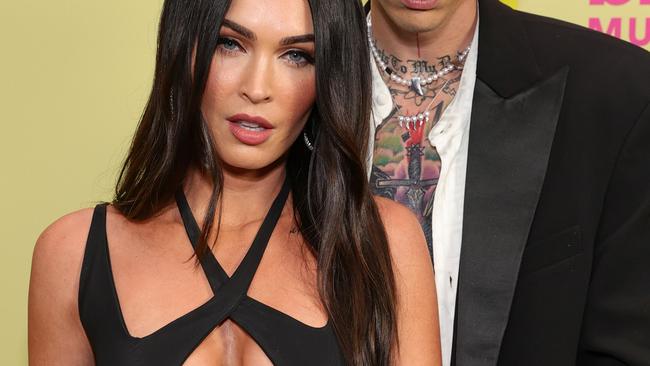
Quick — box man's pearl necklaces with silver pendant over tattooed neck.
[368,17,471,129]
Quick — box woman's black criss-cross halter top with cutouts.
[79,182,344,366]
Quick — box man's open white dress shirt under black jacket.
[368,20,478,366]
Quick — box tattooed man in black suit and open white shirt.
[368,0,650,366]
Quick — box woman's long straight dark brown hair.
[113,0,397,366]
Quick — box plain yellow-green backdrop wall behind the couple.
[0,0,650,365]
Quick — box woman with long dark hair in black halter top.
[29,0,439,365]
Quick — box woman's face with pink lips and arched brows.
[201,0,316,170]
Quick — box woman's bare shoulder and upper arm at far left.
[28,208,100,365]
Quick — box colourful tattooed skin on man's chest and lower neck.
[370,46,462,253]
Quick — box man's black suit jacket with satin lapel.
[453,0,650,366]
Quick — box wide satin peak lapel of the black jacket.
[455,68,568,366]
